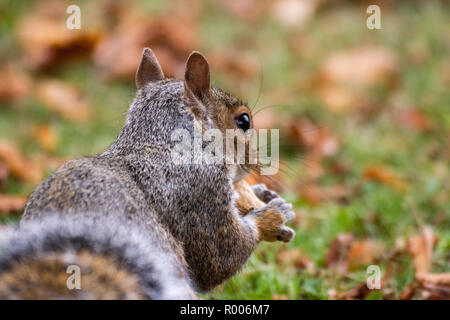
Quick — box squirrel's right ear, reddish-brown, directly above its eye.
[184,51,210,100]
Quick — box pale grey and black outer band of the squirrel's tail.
[0,214,192,299]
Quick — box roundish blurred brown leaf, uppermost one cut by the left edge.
[0,65,31,102]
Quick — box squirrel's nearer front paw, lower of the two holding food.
[249,198,295,242]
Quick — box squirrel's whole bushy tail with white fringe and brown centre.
[0,215,195,299]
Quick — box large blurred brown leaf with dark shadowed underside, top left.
[18,1,101,69]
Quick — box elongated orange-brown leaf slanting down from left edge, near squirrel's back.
[0,140,44,184]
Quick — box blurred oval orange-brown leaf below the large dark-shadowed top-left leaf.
[36,80,90,122]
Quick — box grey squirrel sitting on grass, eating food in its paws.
[0,48,294,299]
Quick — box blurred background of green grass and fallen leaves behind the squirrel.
[0,0,450,299]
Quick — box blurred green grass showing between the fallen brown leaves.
[0,1,450,299]
